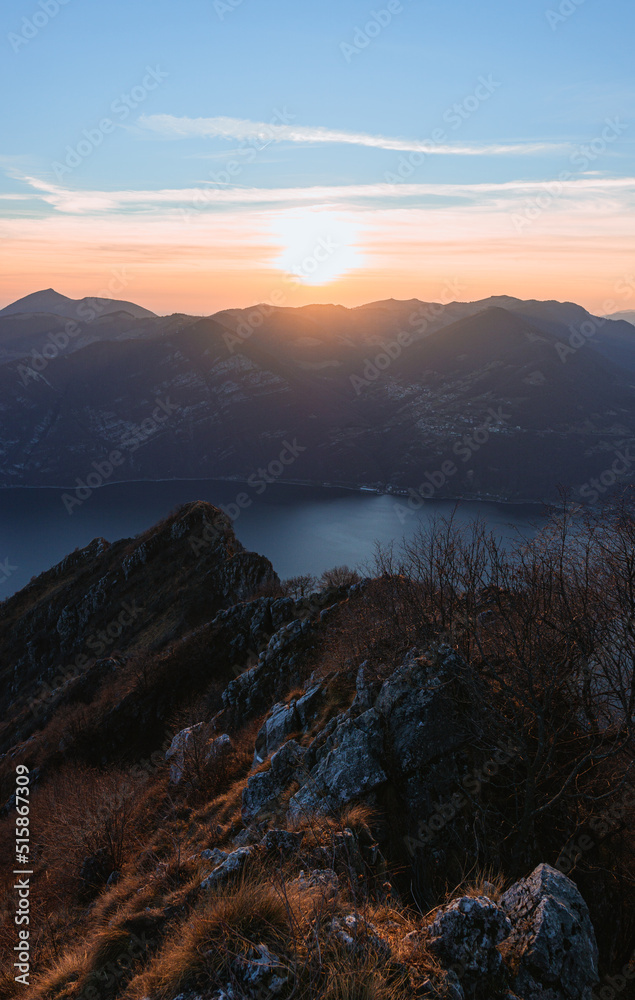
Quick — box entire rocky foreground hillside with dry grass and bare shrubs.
[0,504,635,1000]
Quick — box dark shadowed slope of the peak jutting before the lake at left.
[0,502,277,748]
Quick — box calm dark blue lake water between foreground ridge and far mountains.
[0,480,546,600]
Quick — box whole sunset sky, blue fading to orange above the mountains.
[0,0,635,315]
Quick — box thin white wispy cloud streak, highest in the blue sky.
[137,115,568,156]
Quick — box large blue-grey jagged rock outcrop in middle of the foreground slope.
[241,648,466,821]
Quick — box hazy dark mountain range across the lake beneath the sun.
[0,289,635,503]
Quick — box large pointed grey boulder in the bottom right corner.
[500,864,598,1000]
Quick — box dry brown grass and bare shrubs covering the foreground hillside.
[0,496,635,1000]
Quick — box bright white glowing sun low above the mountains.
[273,208,362,285]
